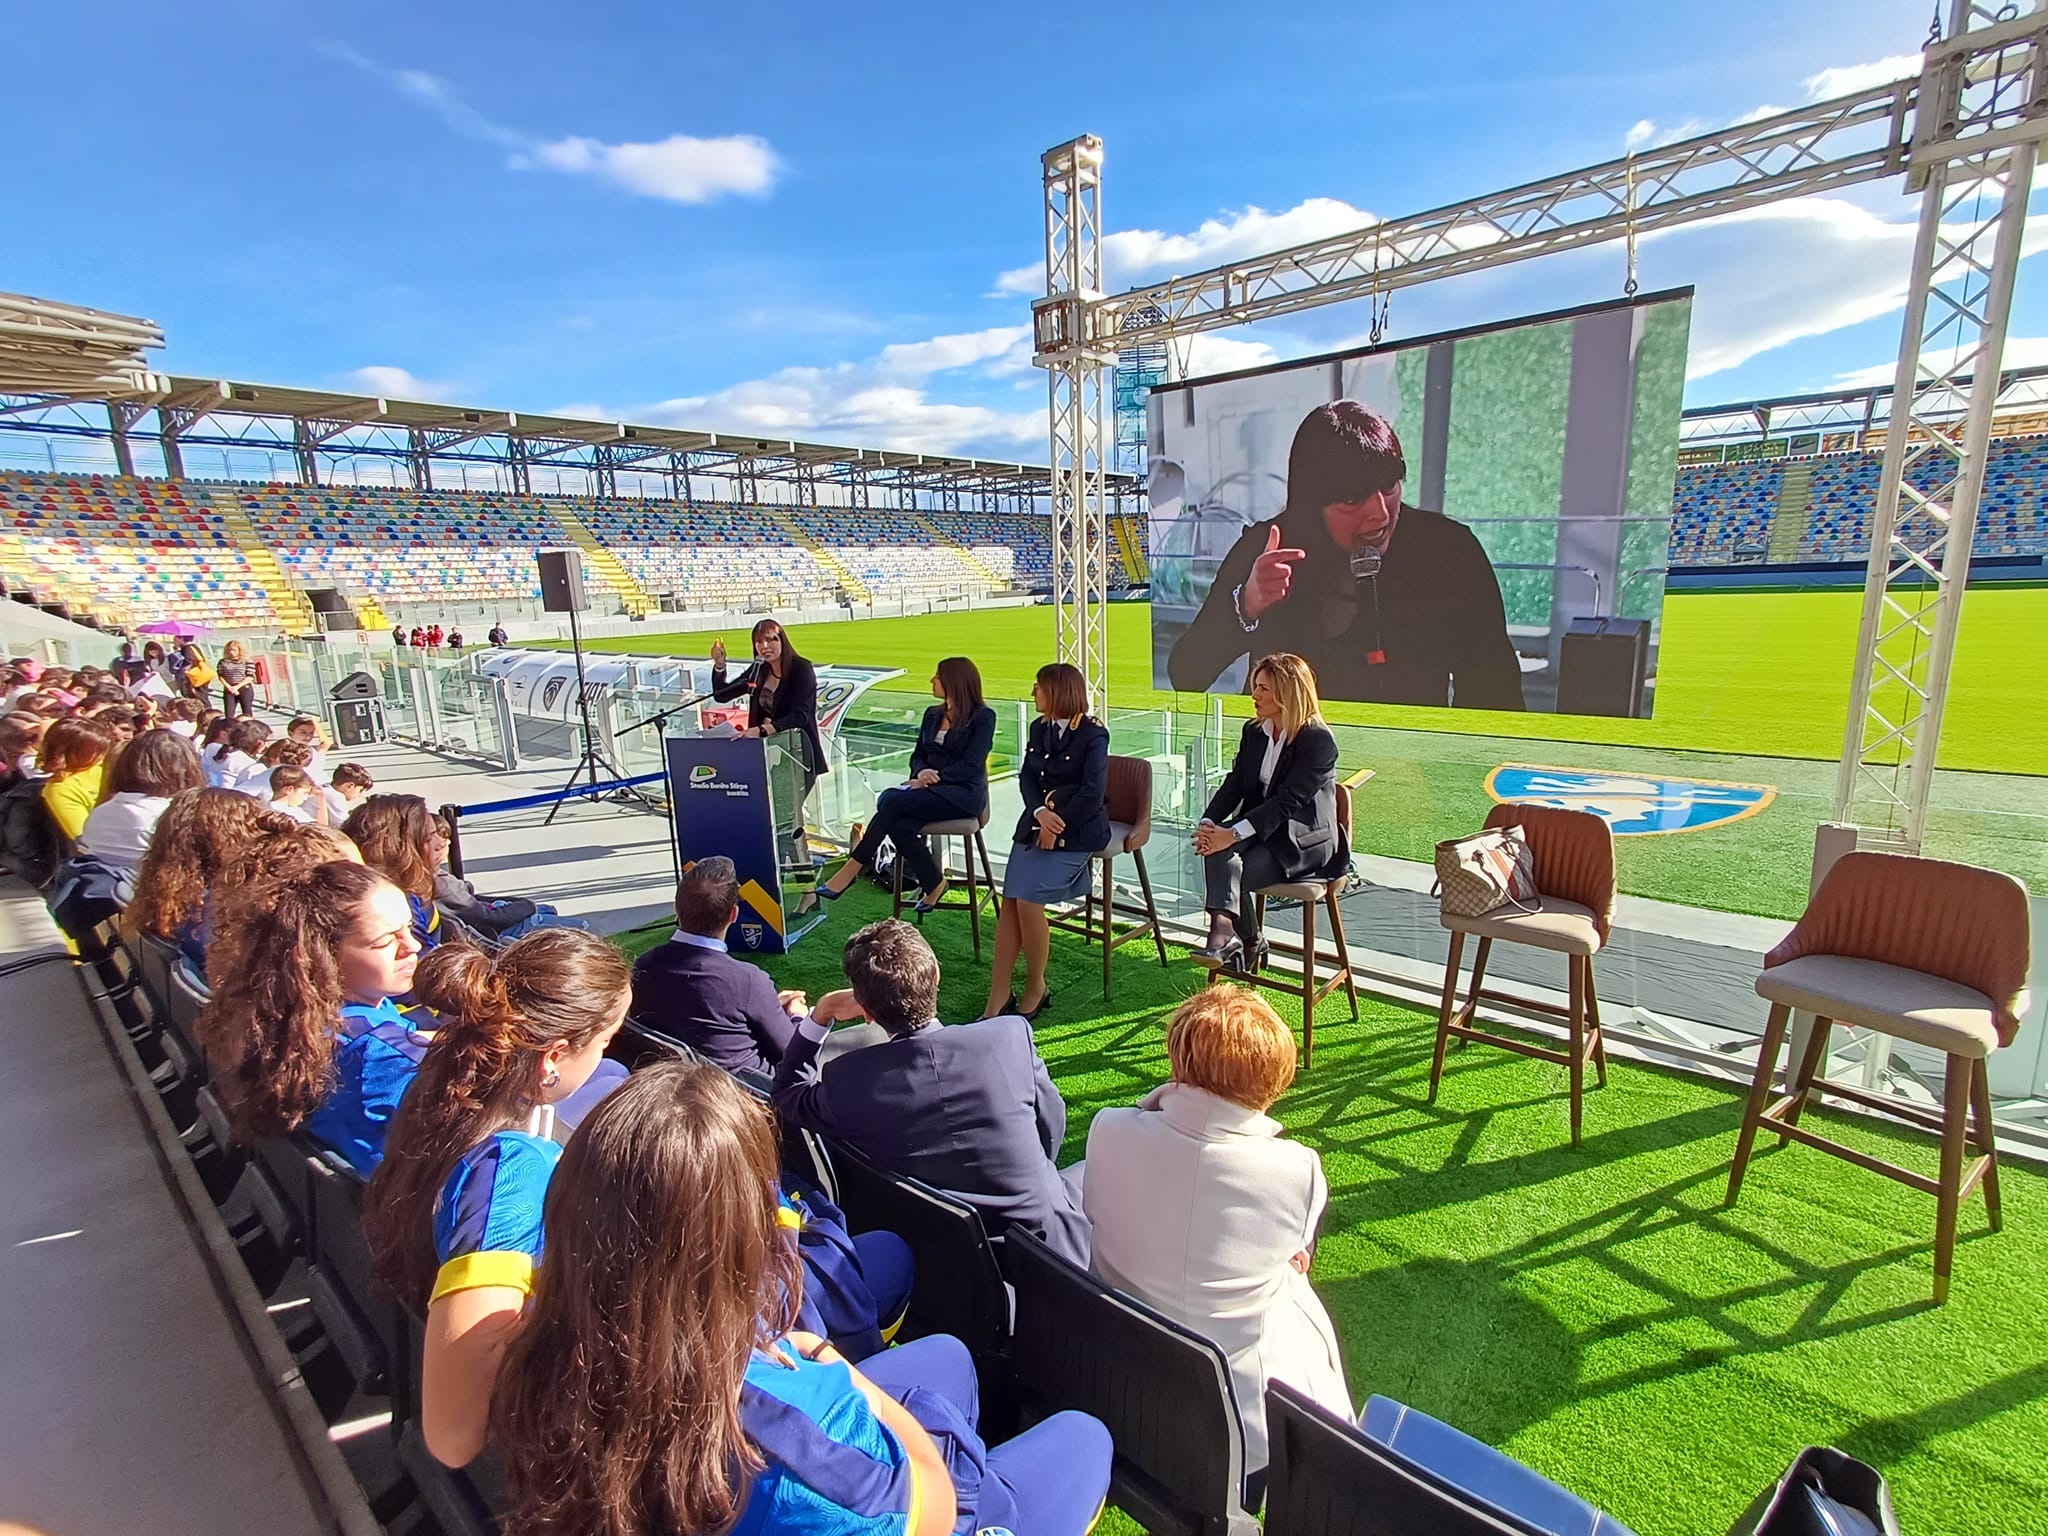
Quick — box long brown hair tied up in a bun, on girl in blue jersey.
[362,928,633,1309]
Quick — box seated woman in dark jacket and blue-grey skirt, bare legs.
[983,662,1110,1018]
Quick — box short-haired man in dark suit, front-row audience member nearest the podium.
[633,858,805,1077]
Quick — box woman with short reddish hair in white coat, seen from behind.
[1083,983,1354,1470]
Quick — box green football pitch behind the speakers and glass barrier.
[565,588,2048,918]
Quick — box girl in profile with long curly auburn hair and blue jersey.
[199,868,424,1174]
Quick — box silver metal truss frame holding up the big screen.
[1034,0,2048,848]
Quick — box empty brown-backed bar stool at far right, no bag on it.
[1726,852,2030,1305]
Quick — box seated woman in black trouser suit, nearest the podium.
[797,655,995,915]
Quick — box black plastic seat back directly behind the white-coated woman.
[1004,1229,1255,1536]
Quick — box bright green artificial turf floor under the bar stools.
[623,885,2048,1536]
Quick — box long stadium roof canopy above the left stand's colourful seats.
[0,295,1137,506]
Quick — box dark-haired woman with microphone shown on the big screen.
[1167,399,1524,709]
